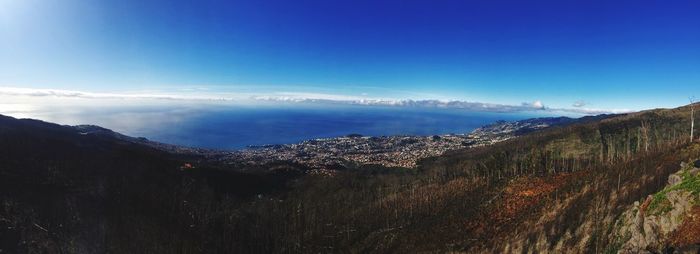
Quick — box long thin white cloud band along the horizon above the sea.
[0,87,633,115]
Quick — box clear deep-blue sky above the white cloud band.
[0,0,700,109]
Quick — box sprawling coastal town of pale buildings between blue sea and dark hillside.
[211,118,571,171]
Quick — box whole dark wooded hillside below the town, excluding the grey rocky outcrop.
[0,104,700,253]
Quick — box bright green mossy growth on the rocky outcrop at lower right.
[648,164,700,215]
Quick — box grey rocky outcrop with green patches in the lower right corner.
[613,160,700,253]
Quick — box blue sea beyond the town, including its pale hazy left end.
[8,104,545,149]
